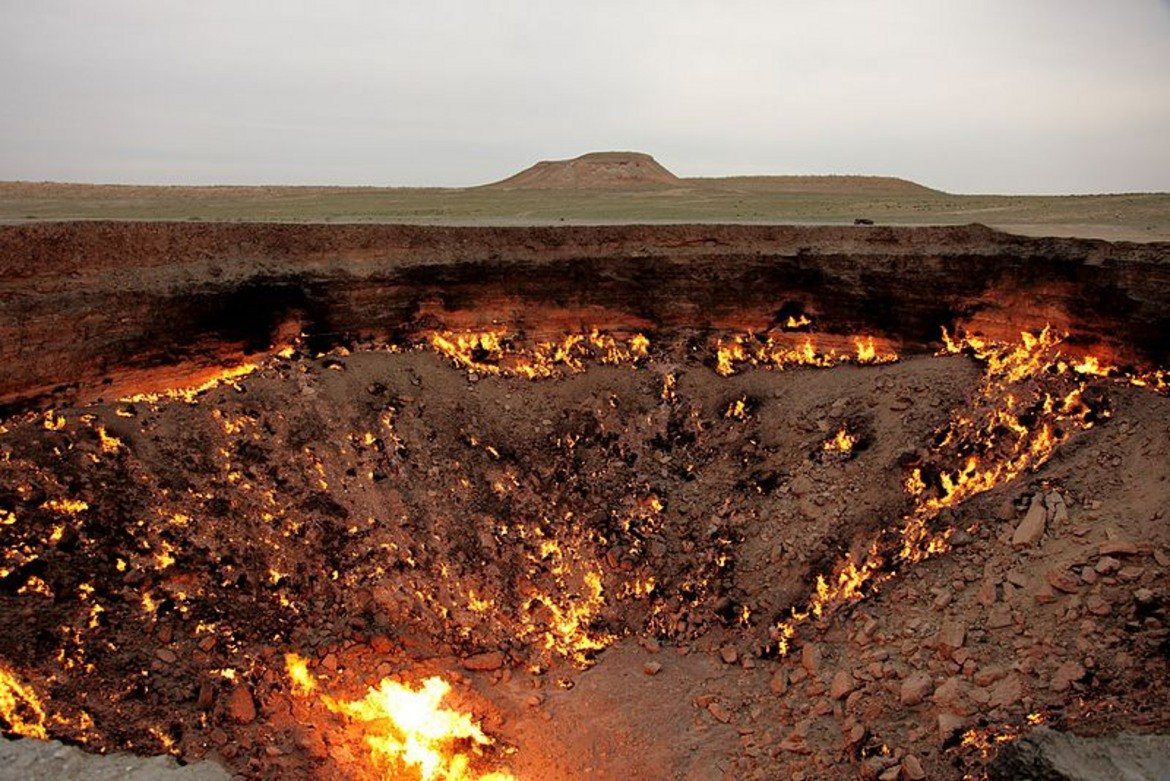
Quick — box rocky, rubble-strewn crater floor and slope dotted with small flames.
[0,336,1170,779]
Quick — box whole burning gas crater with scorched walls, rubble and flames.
[0,223,1170,780]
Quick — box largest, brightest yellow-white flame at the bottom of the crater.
[284,654,515,781]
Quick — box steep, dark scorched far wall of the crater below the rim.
[0,223,1170,405]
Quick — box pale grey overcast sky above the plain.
[0,0,1170,193]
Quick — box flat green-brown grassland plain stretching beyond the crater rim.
[0,177,1170,241]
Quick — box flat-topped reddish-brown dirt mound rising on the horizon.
[489,152,682,189]
